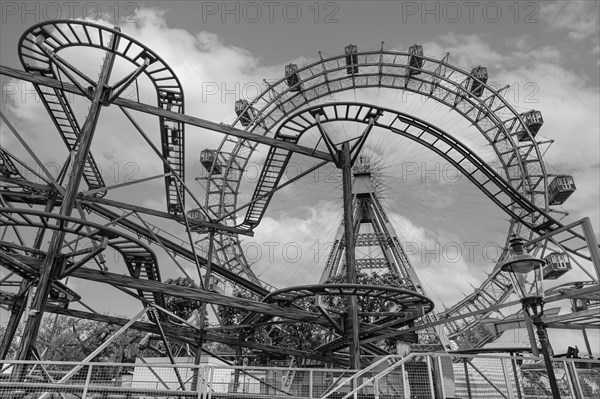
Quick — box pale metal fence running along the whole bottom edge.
[0,353,600,399]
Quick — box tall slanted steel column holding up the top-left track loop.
[13,29,119,364]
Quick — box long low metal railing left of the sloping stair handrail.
[0,358,350,399]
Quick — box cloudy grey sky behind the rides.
[0,1,600,356]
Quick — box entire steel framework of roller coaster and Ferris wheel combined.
[0,21,600,376]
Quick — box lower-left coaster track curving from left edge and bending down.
[0,208,165,307]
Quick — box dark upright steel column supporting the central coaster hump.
[339,142,361,370]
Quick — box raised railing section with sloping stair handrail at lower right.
[323,353,600,399]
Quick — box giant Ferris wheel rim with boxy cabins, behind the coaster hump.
[200,45,597,352]
